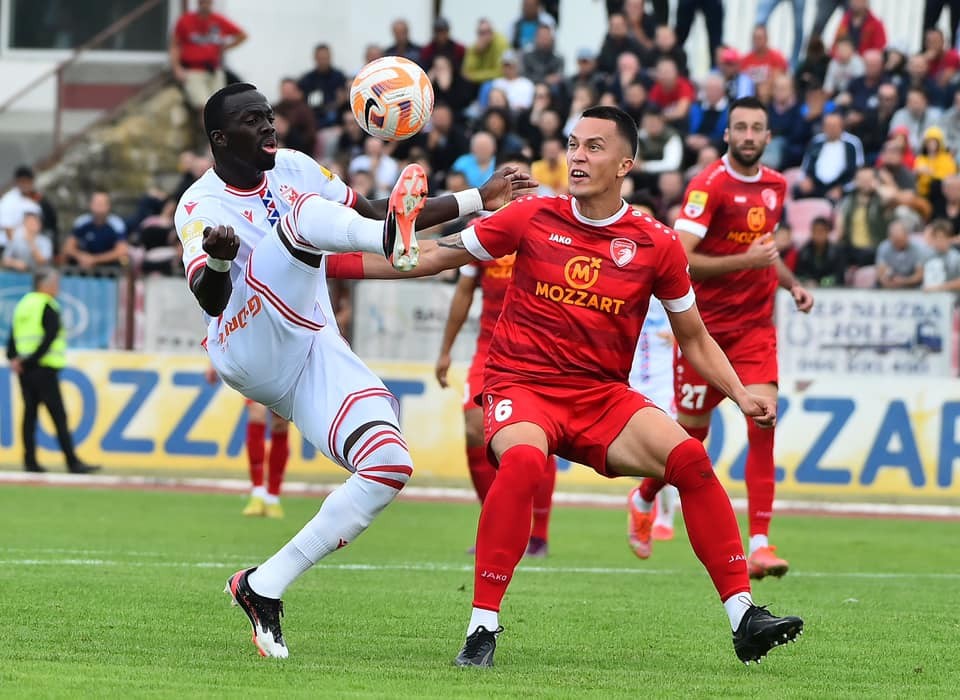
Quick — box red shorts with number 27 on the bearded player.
[673,326,779,416]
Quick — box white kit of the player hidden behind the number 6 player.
[630,297,676,416]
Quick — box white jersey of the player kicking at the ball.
[174,148,357,314]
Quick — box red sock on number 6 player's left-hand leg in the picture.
[473,445,547,610]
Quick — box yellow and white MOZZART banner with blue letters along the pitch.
[0,352,960,500]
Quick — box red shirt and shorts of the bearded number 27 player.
[674,156,786,414]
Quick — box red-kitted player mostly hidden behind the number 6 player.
[436,253,557,557]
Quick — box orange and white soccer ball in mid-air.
[350,56,433,141]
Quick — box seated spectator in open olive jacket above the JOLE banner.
[837,168,889,267]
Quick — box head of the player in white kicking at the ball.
[220,90,277,170]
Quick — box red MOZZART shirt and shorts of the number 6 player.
[462,195,694,476]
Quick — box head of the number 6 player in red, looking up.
[567,117,633,199]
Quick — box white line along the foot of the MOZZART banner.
[0,471,960,519]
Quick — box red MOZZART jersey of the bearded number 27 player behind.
[674,156,787,335]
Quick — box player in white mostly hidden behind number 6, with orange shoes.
[627,297,678,559]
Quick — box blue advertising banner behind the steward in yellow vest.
[0,272,121,350]
